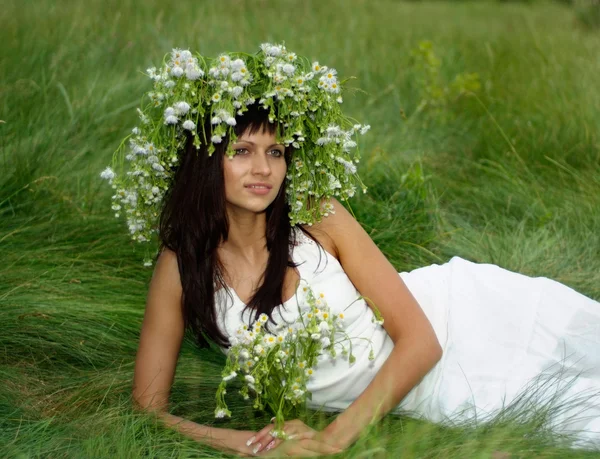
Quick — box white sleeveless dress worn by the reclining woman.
[215,230,600,446]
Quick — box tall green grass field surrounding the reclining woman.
[0,0,600,459]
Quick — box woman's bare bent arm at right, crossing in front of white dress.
[315,199,442,448]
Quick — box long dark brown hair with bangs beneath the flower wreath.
[159,104,320,348]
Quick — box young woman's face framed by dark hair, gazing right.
[223,129,287,217]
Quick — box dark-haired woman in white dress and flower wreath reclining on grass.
[103,45,600,456]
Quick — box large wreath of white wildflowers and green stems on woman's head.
[100,43,370,266]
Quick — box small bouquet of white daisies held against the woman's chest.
[215,285,383,438]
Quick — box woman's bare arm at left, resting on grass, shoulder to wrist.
[133,249,252,454]
